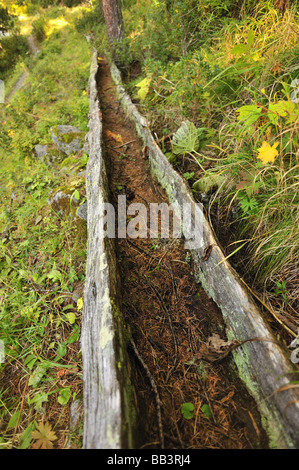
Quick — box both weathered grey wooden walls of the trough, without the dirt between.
[81,50,299,449]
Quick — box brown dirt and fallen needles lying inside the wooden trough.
[97,60,268,449]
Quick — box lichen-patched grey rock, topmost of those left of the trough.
[51,125,85,155]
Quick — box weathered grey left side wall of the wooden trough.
[81,54,134,449]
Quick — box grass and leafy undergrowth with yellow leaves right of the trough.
[89,0,299,335]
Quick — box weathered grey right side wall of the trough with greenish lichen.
[110,63,299,448]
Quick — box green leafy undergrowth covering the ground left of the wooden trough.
[0,8,90,448]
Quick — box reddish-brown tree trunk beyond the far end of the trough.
[102,0,125,44]
